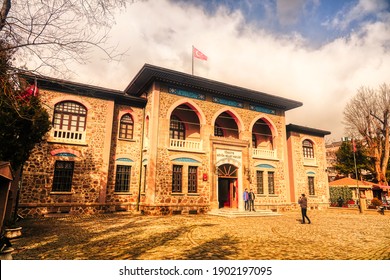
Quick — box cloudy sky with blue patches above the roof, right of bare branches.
[65,0,390,141]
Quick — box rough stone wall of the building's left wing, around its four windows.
[19,90,143,216]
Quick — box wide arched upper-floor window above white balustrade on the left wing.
[53,101,87,132]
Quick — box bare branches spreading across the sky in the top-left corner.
[0,0,132,74]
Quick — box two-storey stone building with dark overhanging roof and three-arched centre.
[19,64,329,215]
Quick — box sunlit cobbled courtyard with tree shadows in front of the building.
[7,209,390,260]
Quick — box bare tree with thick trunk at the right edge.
[344,84,390,185]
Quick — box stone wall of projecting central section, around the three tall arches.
[142,84,289,212]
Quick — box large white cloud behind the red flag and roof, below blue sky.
[61,0,390,139]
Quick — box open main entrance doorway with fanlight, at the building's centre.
[218,164,238,208]
